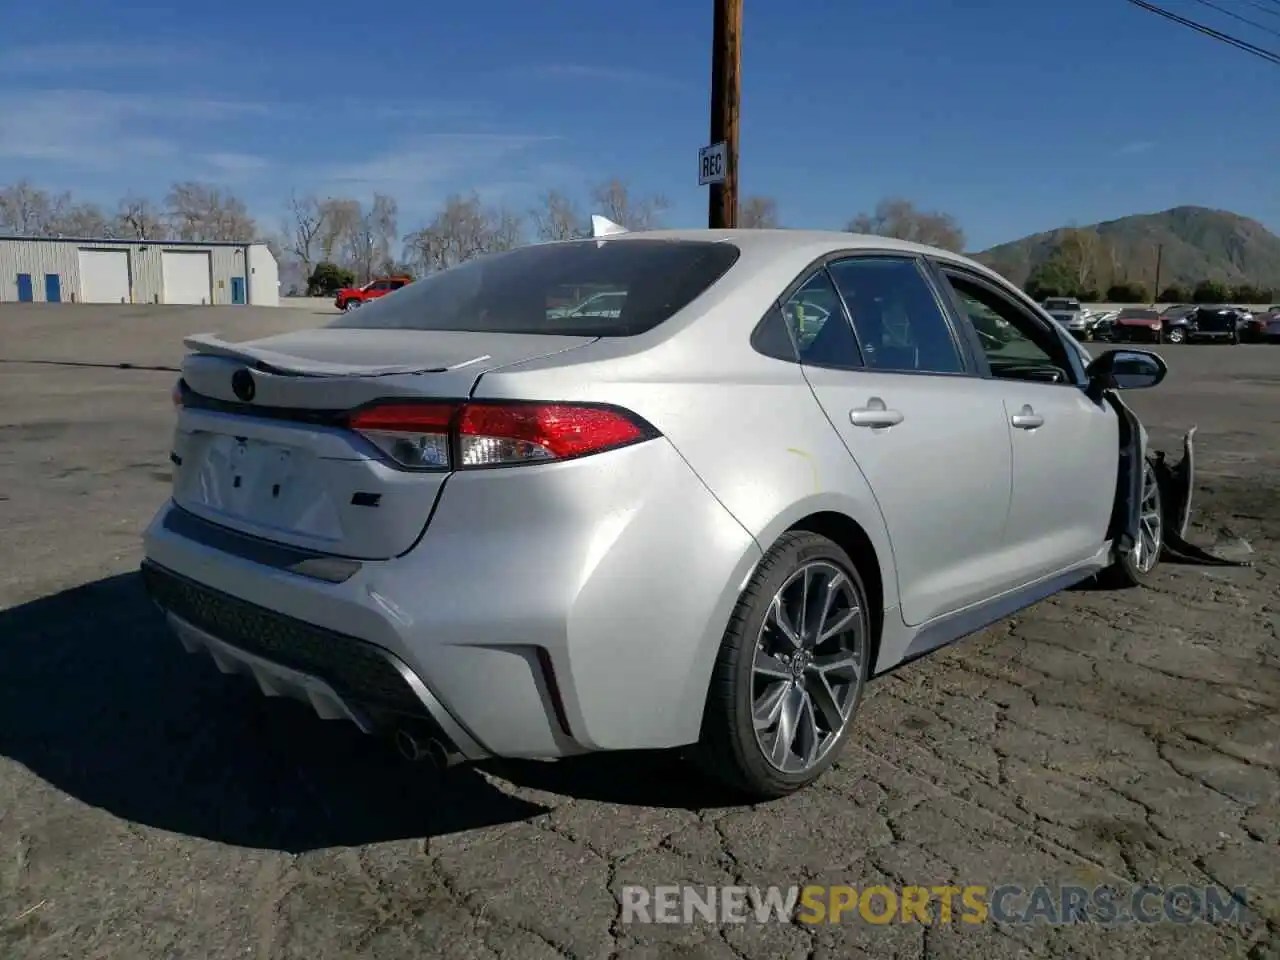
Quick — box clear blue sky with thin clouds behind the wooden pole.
[0,0,1280,248]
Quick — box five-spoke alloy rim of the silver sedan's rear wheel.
[751,561,869,773]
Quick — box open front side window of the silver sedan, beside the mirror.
[945,273,1070,383]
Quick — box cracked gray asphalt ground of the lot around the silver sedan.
[0,306,1280,960]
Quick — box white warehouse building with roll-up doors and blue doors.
[0,237,280,307]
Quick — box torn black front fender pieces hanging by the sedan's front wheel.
[1105,390,1253,567]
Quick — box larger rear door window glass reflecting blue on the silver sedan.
[829,257,964,374]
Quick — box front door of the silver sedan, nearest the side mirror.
[937,262,1120,582]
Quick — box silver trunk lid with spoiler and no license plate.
[173,329,596,559]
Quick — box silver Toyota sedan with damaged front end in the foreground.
[143,230,1166,797]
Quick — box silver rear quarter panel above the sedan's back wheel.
[475,280,897,624]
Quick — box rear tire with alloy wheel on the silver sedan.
[690,531,873,800]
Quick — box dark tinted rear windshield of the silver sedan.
[330,239,740,337]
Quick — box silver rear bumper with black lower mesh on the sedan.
[143,440,760,759]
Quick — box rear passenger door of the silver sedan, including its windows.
[781,255,1012,626]
